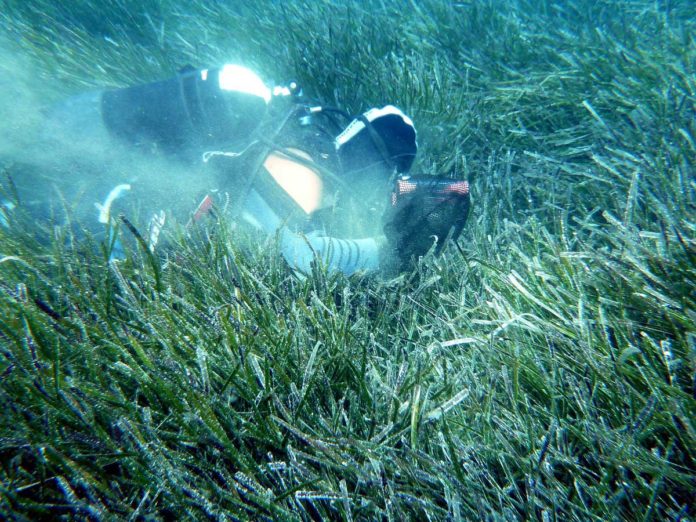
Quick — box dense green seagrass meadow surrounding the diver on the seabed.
[0,0,696,521]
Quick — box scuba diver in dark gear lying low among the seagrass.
[32,64,469,275]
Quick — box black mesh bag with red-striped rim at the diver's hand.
[384,176,469,269]
